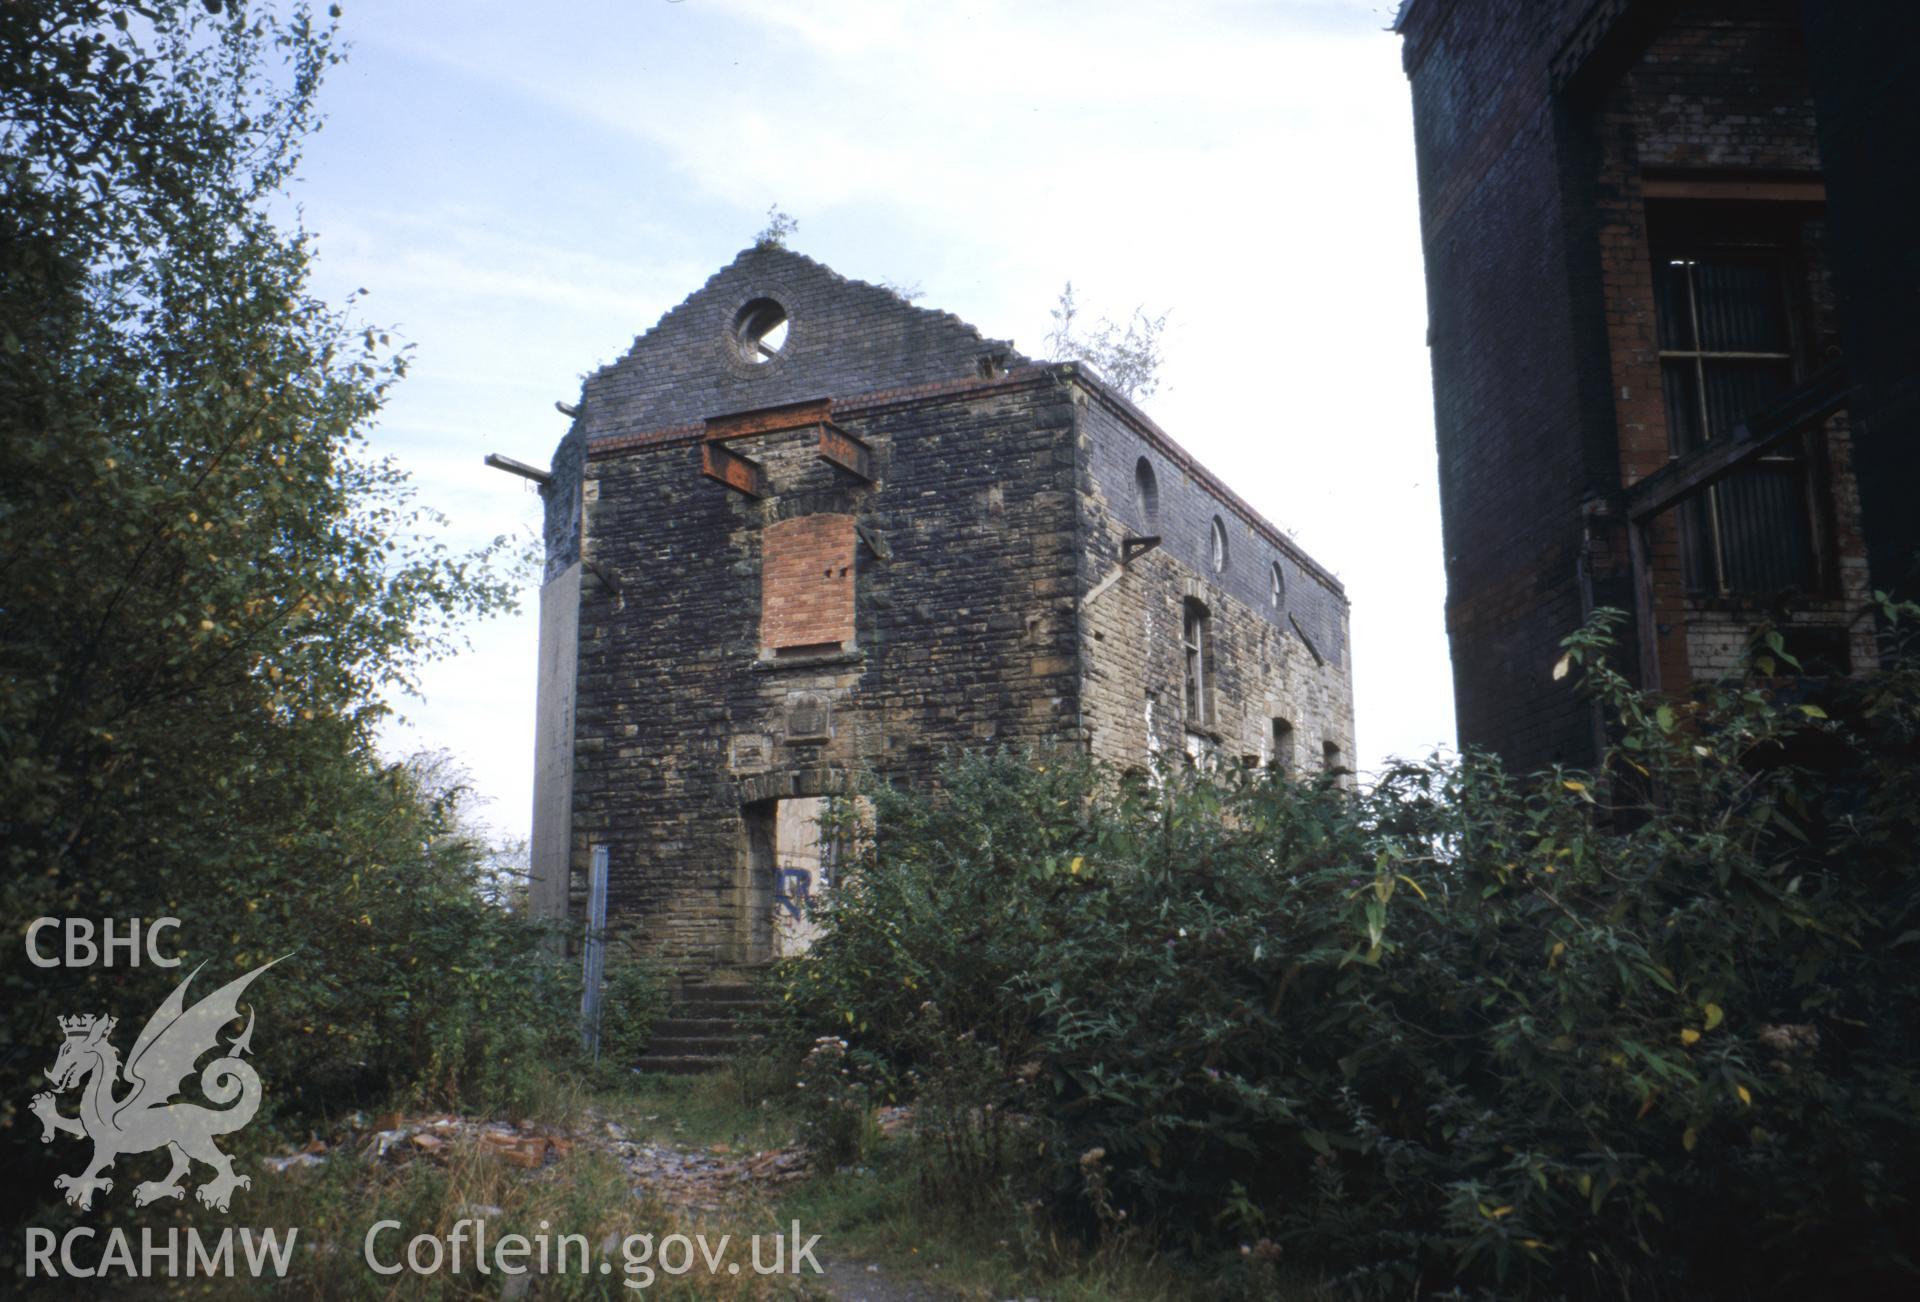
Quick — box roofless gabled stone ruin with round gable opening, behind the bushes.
[510,246,1354,966]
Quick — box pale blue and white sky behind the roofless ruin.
[294,0,1453,835]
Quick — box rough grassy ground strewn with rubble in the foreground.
[63,1066,1325,1302]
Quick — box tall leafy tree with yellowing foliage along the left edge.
[0,0,560,1244]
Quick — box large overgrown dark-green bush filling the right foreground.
[785,607,1920,1298]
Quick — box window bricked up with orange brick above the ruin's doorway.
[760,515,854,657]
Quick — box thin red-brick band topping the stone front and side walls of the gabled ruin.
[588,361,1352,609]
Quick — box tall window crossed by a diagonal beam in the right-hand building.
[1653,240,1814,595]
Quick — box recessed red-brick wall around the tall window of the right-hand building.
[1594,0,1872,687]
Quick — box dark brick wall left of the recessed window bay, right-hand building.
[1404,0,1613,764]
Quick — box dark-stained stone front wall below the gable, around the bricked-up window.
[574,373,1077,962]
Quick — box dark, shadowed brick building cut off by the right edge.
[1396,0,1920,766]
